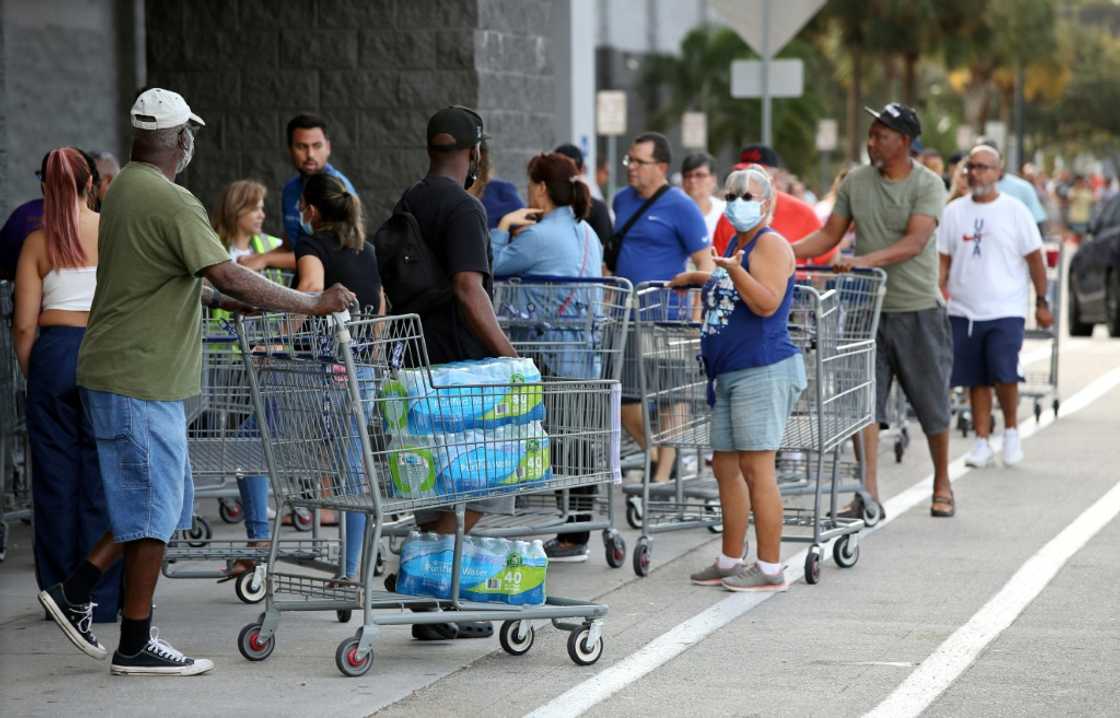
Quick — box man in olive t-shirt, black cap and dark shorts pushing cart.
[793,102,955,521]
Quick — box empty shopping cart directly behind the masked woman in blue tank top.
[625,270,885,584]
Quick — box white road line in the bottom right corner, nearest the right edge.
[865,474,1120,718]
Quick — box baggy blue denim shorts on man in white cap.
[82,389,195,543]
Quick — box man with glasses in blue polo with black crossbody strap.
[613,132,713,482]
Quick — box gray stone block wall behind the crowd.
[147,0,552,226]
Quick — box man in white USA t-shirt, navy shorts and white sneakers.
[937,144,1054,467]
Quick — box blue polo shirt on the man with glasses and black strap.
[613,187,708,286]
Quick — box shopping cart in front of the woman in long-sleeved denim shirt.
[472,276,632,568]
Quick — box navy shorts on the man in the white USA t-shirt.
[949,317,1026,386]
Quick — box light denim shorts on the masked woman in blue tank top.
[710,353,809,451]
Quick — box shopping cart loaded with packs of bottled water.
[237,315,620,675]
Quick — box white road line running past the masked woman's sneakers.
[528,369,1120,718]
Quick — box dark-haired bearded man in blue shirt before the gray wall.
[237,114,357,271]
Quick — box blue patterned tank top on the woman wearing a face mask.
[700,227,799,383]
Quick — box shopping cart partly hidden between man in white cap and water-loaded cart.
[162,318,339,604]
